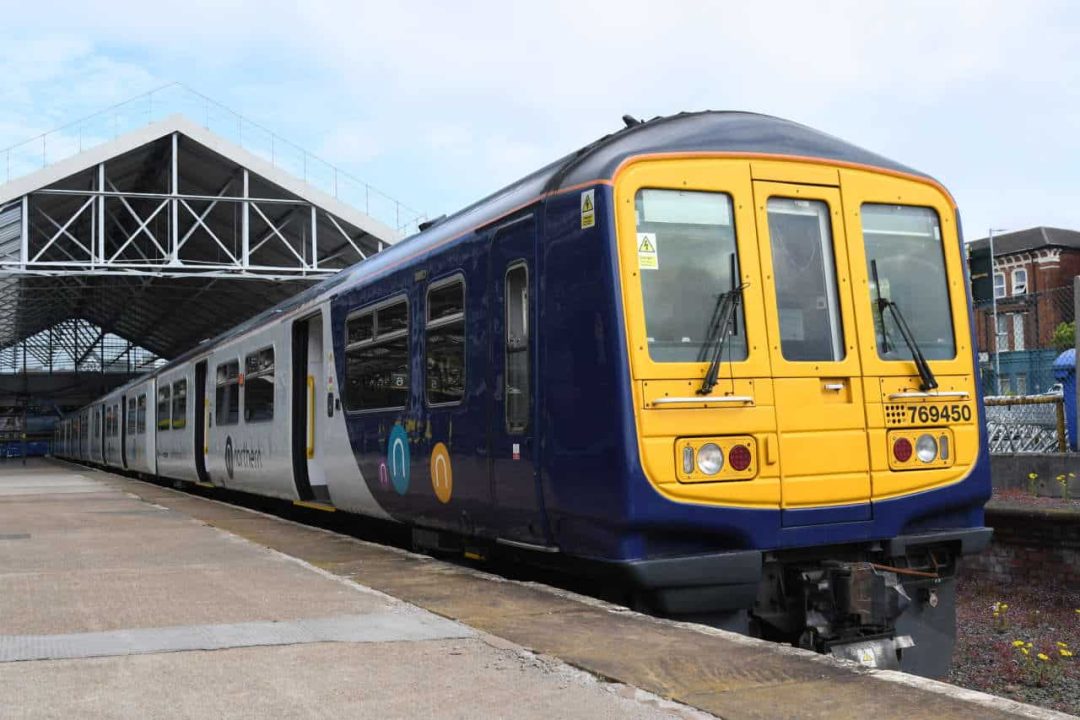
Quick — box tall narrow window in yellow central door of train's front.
[767,198,846,362]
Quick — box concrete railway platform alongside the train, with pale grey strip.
[0,460,1066,720]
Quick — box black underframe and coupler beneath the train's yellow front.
[627,528,990,677]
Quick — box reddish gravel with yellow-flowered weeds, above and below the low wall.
[948,493,1080,715]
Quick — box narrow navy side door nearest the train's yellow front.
[488,215,548,544]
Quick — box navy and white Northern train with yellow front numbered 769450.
[54,111,990,676]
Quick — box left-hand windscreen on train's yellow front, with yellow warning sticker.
[635,189,746,363]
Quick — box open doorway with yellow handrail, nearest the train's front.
[291,315,317,502]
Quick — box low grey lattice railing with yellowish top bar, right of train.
[985,395,1068,454]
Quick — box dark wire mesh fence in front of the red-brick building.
[975,285,1076,396]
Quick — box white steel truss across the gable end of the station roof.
[0,132,384,280]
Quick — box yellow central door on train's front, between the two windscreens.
[754,181,872,526]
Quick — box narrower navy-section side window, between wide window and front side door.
[424,279,465,405]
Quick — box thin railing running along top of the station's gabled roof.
[0,83,426,235]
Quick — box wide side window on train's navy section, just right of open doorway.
[345,299,409,410]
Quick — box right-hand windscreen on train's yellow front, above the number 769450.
[862,203,956,361]
